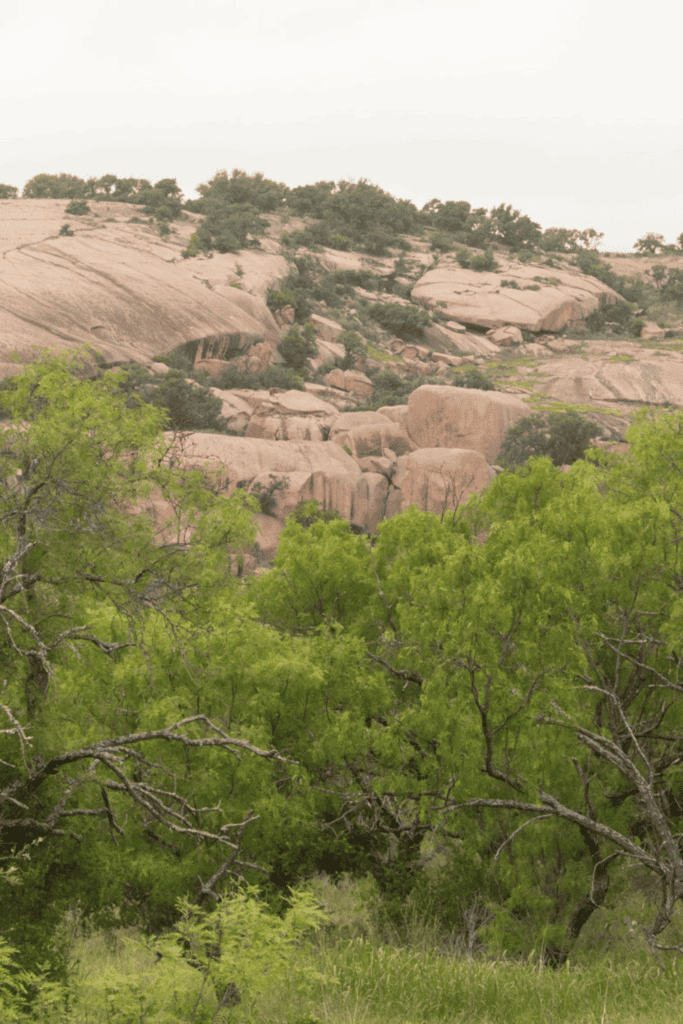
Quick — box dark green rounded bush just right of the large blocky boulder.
[498,410,603,468]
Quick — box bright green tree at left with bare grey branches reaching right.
[0,353,309,983]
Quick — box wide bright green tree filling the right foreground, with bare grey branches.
[251,412,683,965]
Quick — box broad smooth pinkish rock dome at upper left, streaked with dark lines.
[0,199,289,362]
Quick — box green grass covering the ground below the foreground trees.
[31,878,683,1024]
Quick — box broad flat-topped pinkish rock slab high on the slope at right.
[411,253,621,332]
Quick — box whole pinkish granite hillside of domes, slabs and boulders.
[0,200,683,567]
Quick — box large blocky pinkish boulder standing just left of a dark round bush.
[405,384,529,465]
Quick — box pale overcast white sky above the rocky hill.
[0,0,683,252]
